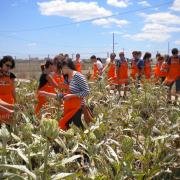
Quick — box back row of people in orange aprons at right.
[88,48,180,102]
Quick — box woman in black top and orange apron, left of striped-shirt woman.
[35,60,59,116]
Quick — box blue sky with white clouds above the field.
[0,0,180,58]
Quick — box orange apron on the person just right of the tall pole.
[116,60,128,85]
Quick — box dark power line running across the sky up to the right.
[0,0,173,33]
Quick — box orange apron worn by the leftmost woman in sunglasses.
[0,76,15,124]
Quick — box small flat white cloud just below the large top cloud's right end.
[92,18,128,27]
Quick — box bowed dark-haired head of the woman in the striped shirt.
[57,58,76,75]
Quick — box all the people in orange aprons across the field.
[0,48,180,130]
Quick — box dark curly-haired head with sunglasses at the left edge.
[0,56,15,72]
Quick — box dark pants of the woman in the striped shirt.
[67,109,84,128]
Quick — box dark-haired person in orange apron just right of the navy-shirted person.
[143,52,151,80]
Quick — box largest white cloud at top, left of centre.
[37,0,112,21]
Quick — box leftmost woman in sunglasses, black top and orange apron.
[0,56,16,125]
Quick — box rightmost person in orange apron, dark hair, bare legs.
[163,48,180,102]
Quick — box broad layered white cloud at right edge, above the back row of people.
[124,12,180,42]
